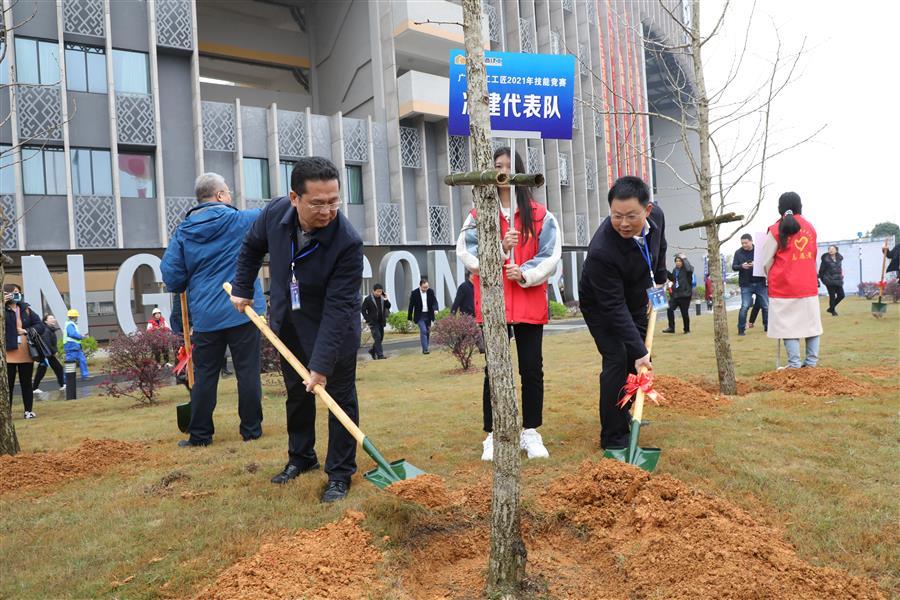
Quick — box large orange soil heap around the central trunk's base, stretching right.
[396,460,884,600]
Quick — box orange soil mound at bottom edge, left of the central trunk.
[196,510,382,600]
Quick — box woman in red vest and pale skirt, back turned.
[763,192,822,369]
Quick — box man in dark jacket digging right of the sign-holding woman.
[578,176,668,448]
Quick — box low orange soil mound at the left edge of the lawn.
[0,440,145,495]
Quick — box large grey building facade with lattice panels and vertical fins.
[0,0,700,337]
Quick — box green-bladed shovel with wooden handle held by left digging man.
[222,283,425,490]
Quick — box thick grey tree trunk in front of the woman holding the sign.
[463,0,526,598]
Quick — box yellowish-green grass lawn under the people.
[0,298,900,598]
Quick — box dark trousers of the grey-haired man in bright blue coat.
[188,323,262,442]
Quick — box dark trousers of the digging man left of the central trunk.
[279,321,359,483]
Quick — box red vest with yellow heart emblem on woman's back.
[768,215,819,298]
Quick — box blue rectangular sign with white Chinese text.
[449,50,575,140]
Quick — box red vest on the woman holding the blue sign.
[470,200,549,325]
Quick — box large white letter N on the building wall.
[22,254,88,334]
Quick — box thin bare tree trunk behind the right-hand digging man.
[691,0,737,394]
